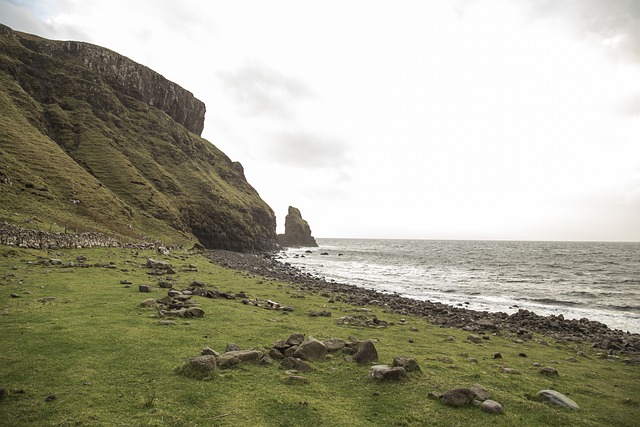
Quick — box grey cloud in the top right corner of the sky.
[530,0,640,63]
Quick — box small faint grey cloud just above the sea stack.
[269,132,352,171]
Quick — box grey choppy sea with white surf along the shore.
[280,239,640,333]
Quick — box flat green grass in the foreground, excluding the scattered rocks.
[0,248,640,426]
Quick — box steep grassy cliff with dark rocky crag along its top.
[0,25,276,251]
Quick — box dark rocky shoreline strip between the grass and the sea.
[203,250,640,356]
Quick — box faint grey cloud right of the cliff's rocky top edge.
[218,63,311,118]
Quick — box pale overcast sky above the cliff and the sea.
[0,0,640,241]
